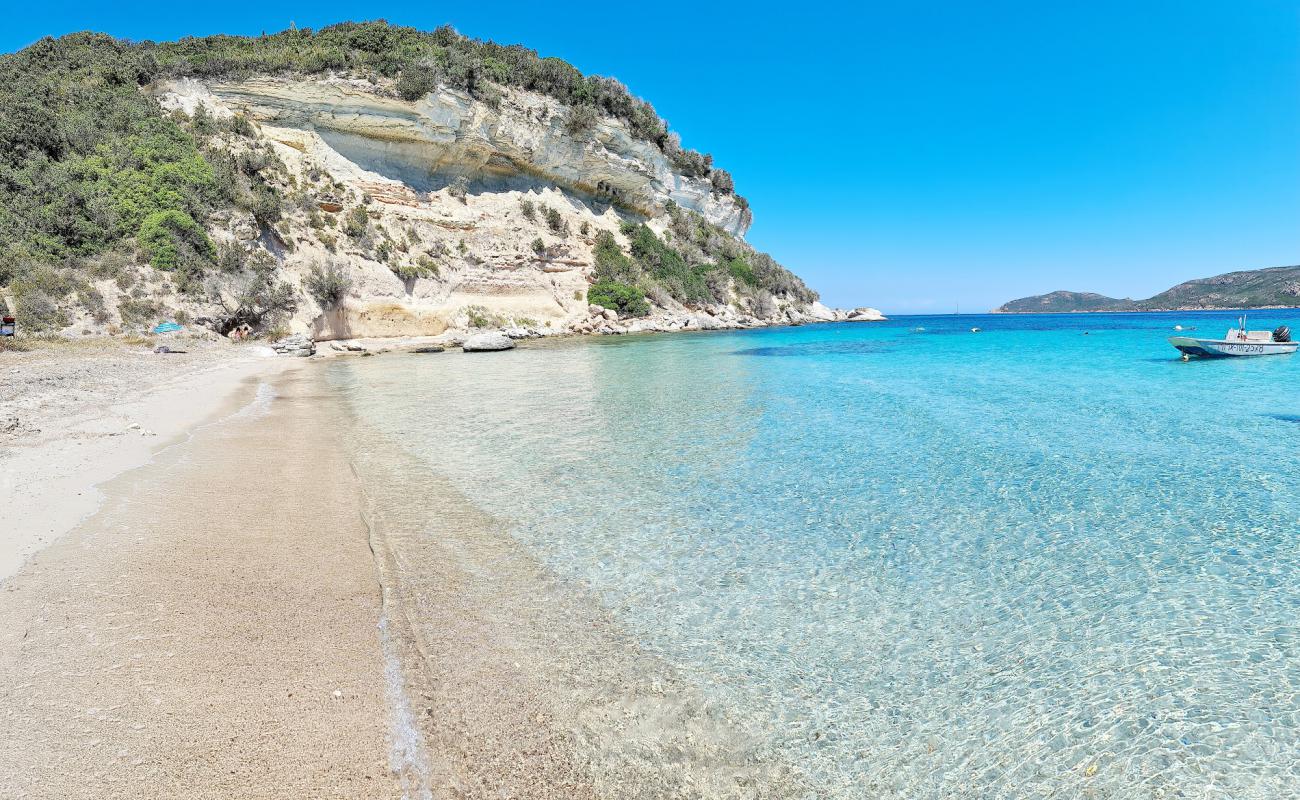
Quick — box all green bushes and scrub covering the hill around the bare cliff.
[0,21,816,330]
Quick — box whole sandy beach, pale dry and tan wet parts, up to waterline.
[0,350,399,797]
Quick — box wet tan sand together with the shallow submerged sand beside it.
[0,346,807,800]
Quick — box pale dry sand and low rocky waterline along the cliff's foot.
[0,317,885,584]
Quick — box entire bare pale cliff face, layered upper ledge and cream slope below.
[144,71,875,341]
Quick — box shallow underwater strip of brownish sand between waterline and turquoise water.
[346,379,814,800]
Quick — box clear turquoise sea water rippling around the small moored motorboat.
[332,311,1300,797]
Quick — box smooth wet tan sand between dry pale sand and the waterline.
[0,369,400,799]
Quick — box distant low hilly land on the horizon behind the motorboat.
[993,265,1300,313]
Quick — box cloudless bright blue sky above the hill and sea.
[0,0,1300,313]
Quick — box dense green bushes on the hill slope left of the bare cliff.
[0,34,295,329]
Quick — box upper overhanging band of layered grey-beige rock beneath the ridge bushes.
[187,77,750,237]
